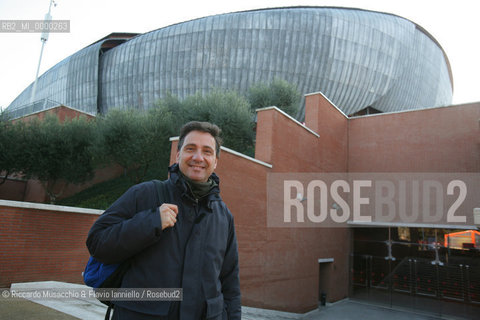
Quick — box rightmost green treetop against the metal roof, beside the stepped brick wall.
[247,78,301,118]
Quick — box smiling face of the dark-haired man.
[177,131,217,182]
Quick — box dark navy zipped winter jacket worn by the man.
[87,164,241,319]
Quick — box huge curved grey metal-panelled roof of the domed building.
[8,7,453,118]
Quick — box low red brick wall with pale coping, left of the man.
[0,201,98,287]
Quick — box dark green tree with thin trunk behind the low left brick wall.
[18,115,94,203]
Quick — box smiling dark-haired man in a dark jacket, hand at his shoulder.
[87,121,241,319]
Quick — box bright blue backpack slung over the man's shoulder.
[83,180,168,320]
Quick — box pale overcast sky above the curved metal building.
[0,0,480,108]
